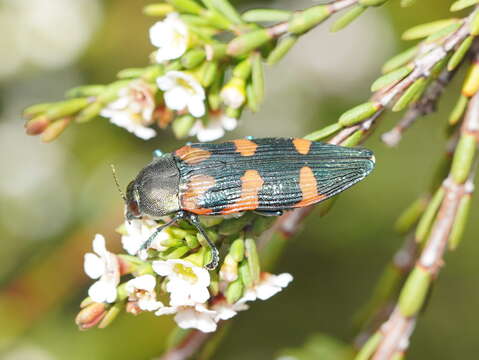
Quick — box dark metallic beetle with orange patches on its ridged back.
[125,138,375,270]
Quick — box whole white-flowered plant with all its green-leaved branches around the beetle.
[24,0,479,360]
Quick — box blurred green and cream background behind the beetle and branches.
[0,0,479,360]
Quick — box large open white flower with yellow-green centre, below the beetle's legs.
[153,259,210,307]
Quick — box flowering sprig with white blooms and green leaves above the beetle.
[24,0,387,142]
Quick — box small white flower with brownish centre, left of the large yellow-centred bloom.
[126,275,163,311]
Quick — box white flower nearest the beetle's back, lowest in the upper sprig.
[189,113,238,142]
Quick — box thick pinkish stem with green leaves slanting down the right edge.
[357,86,479,360]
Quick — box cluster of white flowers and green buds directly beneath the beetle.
[77,215,292,332]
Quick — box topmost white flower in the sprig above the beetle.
[150,13,189,63]
